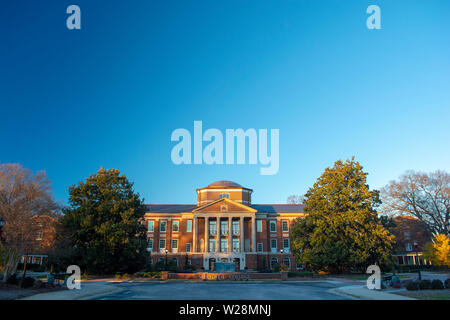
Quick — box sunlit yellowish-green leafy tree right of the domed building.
[291,158,394,273]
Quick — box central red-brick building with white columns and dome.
[145,181,304,270]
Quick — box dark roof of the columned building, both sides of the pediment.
[146,204,304,213]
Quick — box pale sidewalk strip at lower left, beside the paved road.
[21,281,122,300]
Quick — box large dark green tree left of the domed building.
[52,168,147,274]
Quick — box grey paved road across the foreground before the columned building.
[95,282,351,300]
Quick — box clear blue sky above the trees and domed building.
[0,0,450,203]
